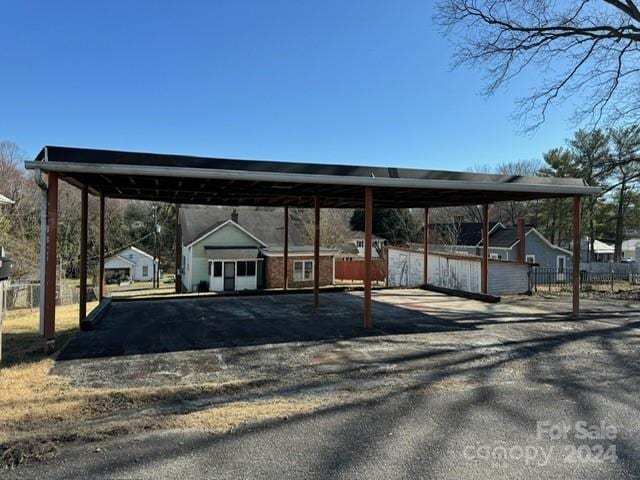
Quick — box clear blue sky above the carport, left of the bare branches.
[0,0,573,170]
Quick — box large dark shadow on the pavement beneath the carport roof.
[57,293,475,361]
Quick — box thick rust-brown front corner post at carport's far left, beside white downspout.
[44,172,58,353]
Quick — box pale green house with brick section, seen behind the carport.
[180,207,337,292]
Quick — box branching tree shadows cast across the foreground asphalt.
[46,321,640,478]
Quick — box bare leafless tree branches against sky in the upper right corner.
[436,0,640,130]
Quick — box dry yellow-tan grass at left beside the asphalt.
[0,304,327,468]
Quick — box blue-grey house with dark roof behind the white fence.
[429,222,572,270]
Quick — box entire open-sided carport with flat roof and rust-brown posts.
[26,146,600,350]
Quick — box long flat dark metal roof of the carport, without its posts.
[26,146,599,208]
